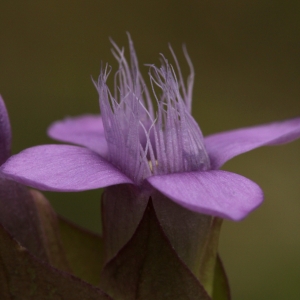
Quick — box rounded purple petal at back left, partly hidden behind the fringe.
[48,115,107,157]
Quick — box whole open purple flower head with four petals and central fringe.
[2,40,300,220]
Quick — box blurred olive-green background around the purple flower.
[0,0,300,300]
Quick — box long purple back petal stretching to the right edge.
[205,118,300,169]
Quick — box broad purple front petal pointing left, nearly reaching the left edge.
[1,145,132,192]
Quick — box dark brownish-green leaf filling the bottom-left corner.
[0,226,111,300]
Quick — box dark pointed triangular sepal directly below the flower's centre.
[100,200,211,300]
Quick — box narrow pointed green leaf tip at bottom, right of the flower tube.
[213,255,231,300]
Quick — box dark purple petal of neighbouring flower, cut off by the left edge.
[0,95,11,165]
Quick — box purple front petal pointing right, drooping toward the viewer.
[147,170,263,221]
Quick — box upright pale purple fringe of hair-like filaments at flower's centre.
[95,39,210,184]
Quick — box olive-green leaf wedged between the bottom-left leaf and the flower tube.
[59,217,104,285]
